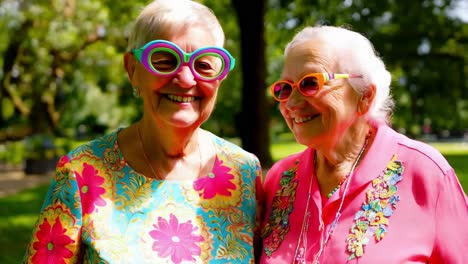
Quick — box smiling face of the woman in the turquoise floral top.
[125,27,221,128]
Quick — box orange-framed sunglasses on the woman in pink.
[270,72,362,102]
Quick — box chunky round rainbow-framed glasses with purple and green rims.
[132,40,236,81]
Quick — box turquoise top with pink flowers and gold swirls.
[25,130,262,263]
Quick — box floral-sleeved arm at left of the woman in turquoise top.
[23,156,82,264]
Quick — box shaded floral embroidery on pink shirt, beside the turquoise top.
[262,160,299,257]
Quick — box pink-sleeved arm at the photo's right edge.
[430,169,468,263]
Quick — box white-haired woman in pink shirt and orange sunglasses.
[261,26,468,263]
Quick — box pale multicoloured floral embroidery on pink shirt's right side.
[346,154,404,260]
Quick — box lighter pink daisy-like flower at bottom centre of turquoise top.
[149,214,203,263]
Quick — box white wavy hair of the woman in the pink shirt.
[284,26,394,123]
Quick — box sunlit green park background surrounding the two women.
[0,0,468,263]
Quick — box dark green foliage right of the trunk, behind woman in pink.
[266,0,468,135]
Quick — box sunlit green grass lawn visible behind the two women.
[0,142,468,264]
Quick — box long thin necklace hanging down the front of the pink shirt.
[293,130,372,264]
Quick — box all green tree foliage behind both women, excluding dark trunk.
[0,0,468,143]
